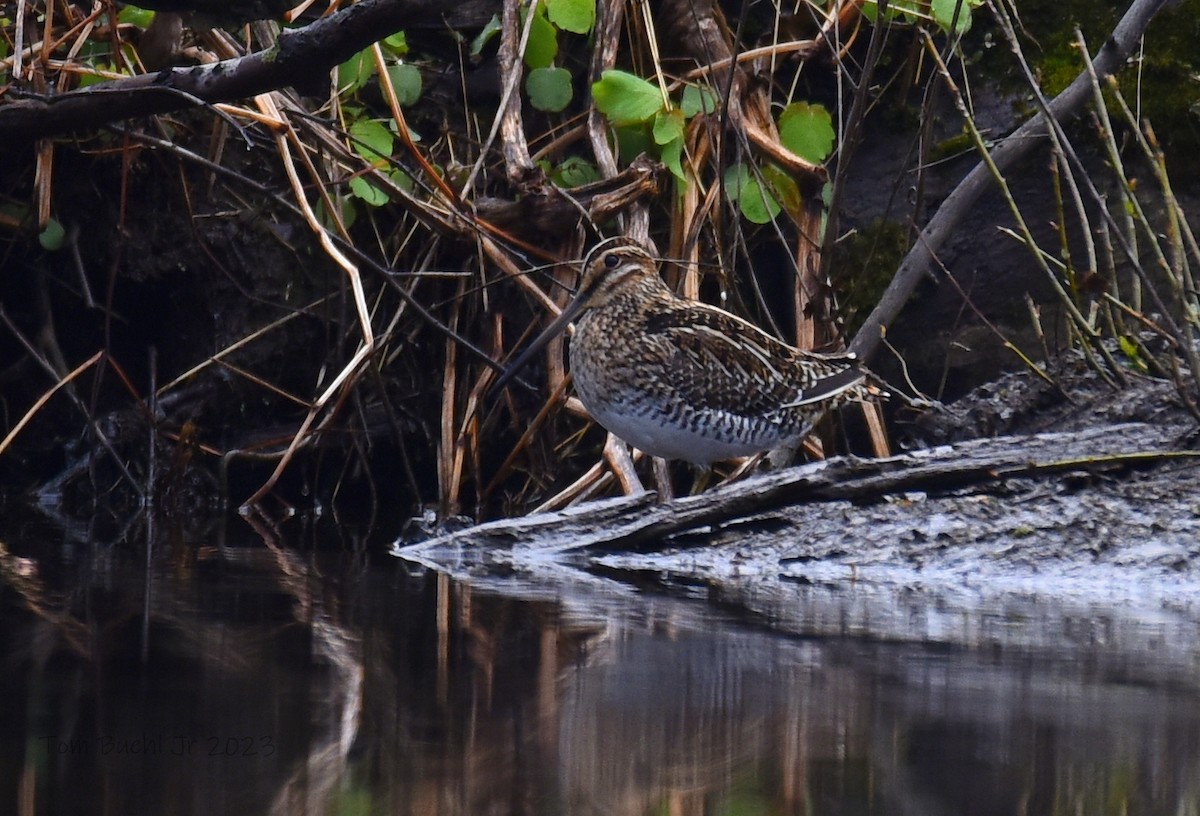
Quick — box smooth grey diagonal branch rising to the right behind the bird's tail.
[850,0,1166,359]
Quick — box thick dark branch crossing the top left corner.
[0,0,453,145]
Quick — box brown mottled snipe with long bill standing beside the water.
[493,236,880,468]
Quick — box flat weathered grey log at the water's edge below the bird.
[394,424,1200,565]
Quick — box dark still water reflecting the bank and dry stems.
[0,513,1200,816]
